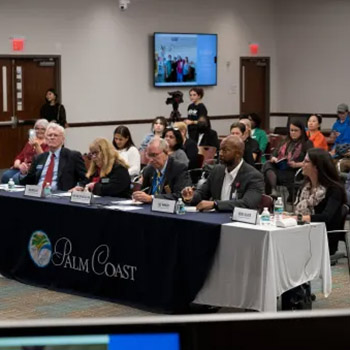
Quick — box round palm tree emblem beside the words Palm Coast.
[28,231,52,267]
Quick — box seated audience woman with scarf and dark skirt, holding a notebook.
[262,120,313,198]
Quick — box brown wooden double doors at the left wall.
[0,56,59,169]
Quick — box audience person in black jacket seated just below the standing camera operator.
[188,116,220,149]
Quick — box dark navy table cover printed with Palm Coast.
[0,192,229,311]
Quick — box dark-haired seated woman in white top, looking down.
[113,125,141,178]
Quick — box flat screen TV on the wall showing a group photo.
[154,33,217,87]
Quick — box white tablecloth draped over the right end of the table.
[194,223,332,311]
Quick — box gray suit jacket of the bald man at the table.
[191,162,265,211]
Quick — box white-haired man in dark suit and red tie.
[20,123,86,191]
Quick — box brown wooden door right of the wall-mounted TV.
[240,57,270,130]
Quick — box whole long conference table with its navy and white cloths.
[0,191,331,312]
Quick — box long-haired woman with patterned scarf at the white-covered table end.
[295,148,346,255]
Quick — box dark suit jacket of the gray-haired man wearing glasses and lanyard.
[142,157,191,199]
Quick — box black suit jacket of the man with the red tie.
[20,147,86,191]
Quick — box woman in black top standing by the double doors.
[40,89,68,128]
